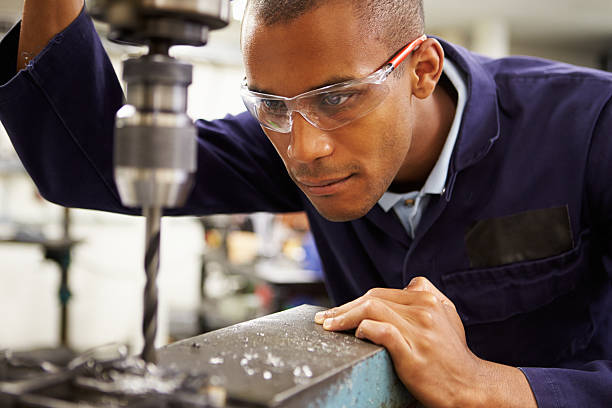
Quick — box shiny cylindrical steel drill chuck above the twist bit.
[114,55,197,207]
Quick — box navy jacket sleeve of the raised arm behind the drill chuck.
[0,9,303,215]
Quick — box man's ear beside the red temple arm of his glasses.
[410,38,444,99]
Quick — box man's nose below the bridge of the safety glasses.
[287,112,334,163]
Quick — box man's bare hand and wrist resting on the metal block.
[315,277,537,408]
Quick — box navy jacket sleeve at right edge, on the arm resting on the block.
[521,93,612,408]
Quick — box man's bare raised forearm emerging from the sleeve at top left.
[17,0,83,70]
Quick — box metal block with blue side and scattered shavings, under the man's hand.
[159,305,414,408]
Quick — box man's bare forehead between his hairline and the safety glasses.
[242,6,386,96]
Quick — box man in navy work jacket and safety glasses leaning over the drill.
[0,0,612,407]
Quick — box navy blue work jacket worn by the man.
[0,7,612,407]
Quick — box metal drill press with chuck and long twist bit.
[89,0,230,363]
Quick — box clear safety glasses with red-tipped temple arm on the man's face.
[241,35,427,133]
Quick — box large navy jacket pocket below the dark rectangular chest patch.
[441,232,593,366]
